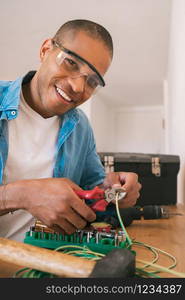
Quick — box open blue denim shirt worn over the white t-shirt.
[0,71,105,189]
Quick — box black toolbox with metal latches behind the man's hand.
[98,152,180,206]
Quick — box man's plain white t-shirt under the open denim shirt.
[0,93,60,241]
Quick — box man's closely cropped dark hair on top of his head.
[53,19,113,57]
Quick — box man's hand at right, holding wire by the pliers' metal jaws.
[101,172,141,208]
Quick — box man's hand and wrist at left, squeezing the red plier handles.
[2,178,96,234]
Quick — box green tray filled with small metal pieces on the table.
[24,221,130,254]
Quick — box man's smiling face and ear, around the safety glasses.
[33,31,111,117]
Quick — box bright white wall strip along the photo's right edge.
[166,0,185,202]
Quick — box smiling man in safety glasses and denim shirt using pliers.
[0,20,141,241]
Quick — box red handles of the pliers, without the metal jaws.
[75,186,109,211]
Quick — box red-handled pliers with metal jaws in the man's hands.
[74,186,126,211]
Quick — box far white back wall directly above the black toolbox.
[115,106,164,153]
